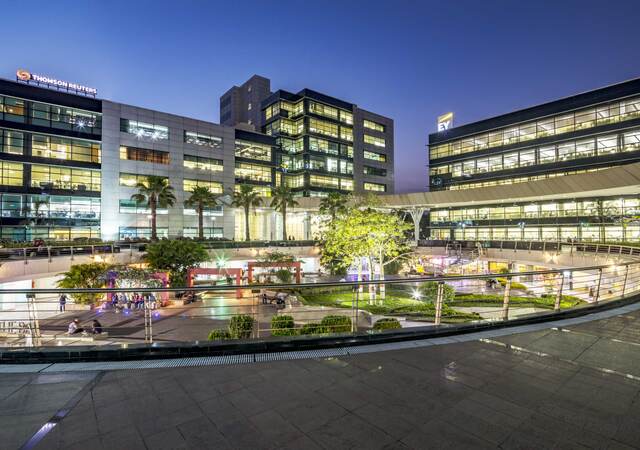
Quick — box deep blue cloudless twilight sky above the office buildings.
[0,0,640,192]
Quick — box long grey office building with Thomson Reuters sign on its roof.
[0,71,284,241]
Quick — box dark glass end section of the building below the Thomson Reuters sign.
[0,80,102,241]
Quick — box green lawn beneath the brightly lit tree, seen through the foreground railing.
[296,289,480,323]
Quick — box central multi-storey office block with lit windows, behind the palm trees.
[225,75,394,197]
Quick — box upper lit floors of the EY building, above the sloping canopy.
[429,79,640,190]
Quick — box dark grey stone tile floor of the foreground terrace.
[0,311,640,449]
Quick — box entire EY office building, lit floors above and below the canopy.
[425,79,640,242]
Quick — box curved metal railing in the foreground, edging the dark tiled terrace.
[0,243,640,351]
